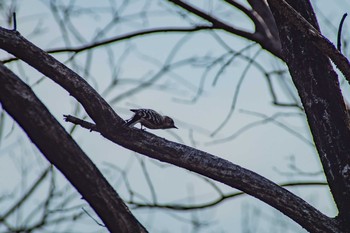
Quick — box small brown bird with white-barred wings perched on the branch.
[124,108,177,129]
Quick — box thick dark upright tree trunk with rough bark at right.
[269,0,350,231]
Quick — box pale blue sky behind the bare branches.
[0,0,350,232]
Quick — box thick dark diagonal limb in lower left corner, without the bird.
[0,62,146,233]
